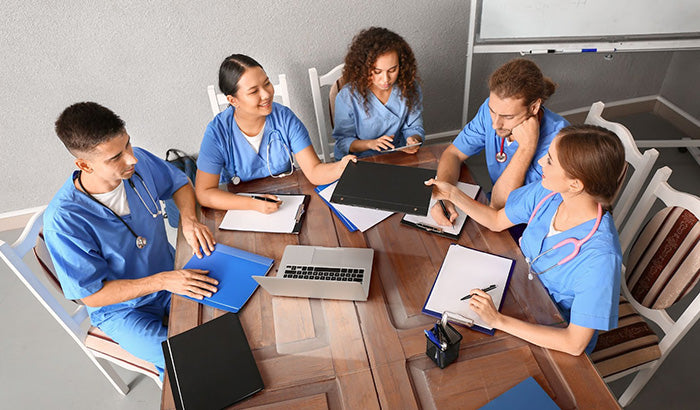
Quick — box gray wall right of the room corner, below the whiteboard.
[661,51,700,120]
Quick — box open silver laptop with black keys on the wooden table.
[253,245,374,300]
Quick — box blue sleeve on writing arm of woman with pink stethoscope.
[569,253,621,330]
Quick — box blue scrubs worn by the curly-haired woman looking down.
[333,84,425,160]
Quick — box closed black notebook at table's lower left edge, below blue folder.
[163,313,265,410]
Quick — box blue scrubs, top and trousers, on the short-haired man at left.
[44,148,188,377]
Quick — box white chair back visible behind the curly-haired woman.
[309,64,345,162]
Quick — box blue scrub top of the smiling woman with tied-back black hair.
[197,103,311,183]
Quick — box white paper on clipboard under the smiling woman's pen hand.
[219,194,304,233]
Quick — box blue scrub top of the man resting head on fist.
[452,98,569,185]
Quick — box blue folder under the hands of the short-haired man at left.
[184,243,274,313]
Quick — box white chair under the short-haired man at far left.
[0,207,163,394]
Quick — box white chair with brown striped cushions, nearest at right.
[591,167,700,407]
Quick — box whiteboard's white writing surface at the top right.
[477,0,700,41]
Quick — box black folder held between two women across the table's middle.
[331,161,436,215]
